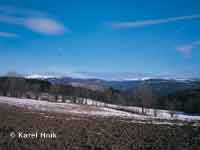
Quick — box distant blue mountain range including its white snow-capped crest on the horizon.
[26,74,200,94]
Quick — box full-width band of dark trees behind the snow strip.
[0,77,200,113]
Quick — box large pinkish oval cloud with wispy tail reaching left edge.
[0,6,70,35]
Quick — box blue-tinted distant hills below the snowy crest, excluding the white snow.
[44,77,200,95]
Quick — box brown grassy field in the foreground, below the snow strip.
[0,105,200,150]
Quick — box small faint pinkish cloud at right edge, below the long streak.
[177,41,200,55]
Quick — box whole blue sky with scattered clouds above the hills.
[0,0,200,77]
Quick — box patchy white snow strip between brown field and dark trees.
[0,96,200,125]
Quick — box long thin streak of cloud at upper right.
[109,14,200,29]
